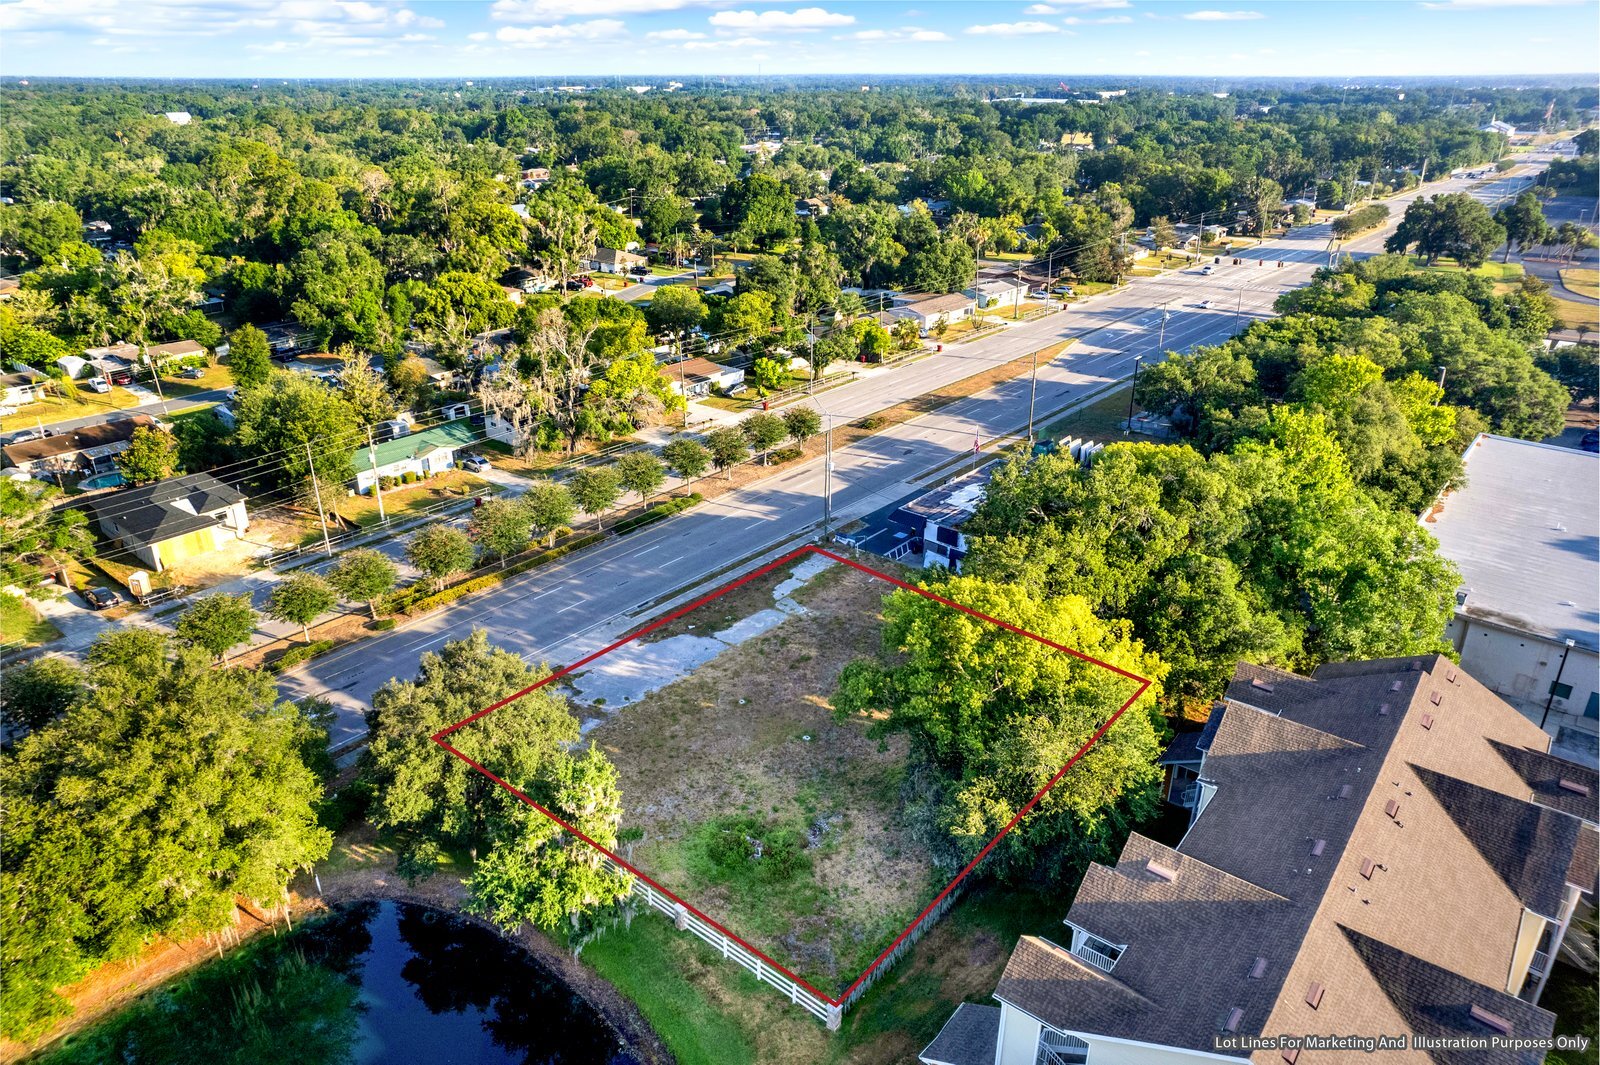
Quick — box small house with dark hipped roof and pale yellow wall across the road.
[90,473,250,572]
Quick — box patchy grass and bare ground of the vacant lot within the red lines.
[589,563,938,991]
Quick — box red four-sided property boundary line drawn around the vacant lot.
[432,544,1150,1007]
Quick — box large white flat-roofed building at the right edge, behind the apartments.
[1422,433,1600,758]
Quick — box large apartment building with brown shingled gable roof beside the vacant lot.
[922,656,1600,1065]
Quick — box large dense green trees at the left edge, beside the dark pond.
[0,628,330,1035]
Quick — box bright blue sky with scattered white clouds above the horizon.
[0,0,1600,80]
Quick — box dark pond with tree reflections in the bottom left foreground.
[45,902,637,1065]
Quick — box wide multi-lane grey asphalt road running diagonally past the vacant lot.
[282,166,1534,745]
